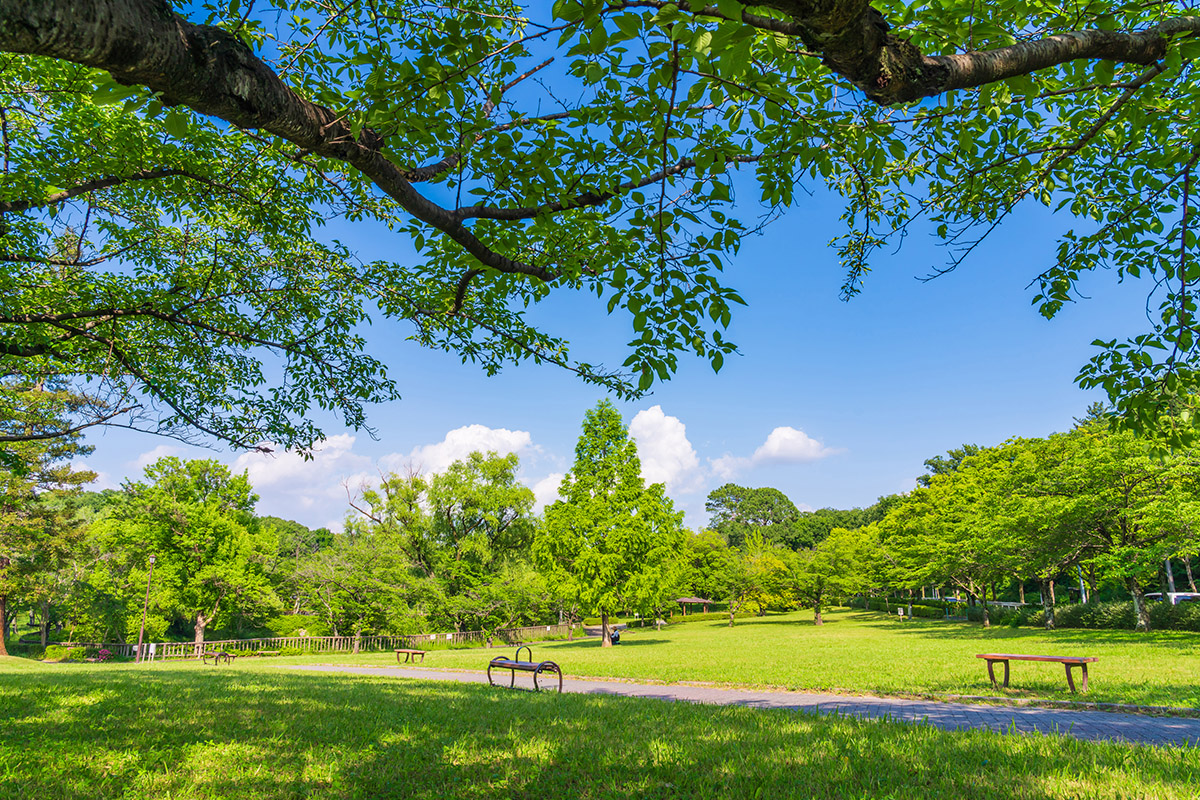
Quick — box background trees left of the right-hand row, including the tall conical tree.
[0,386,892,643]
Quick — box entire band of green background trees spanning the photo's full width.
[0,384,1200,645]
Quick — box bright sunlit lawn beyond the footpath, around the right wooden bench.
[285,610,1200,709]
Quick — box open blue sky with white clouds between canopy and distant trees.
[77,181,1146,528]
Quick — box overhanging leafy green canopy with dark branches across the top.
[7,0,1200,447]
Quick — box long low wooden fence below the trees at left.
[59,624,572,661]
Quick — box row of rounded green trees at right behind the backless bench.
[860,419,1200,630]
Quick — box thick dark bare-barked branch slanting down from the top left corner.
[0,0,557,281]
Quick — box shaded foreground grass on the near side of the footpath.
[0,657,1200,800]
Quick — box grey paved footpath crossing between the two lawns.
[283,666,1200,747]
